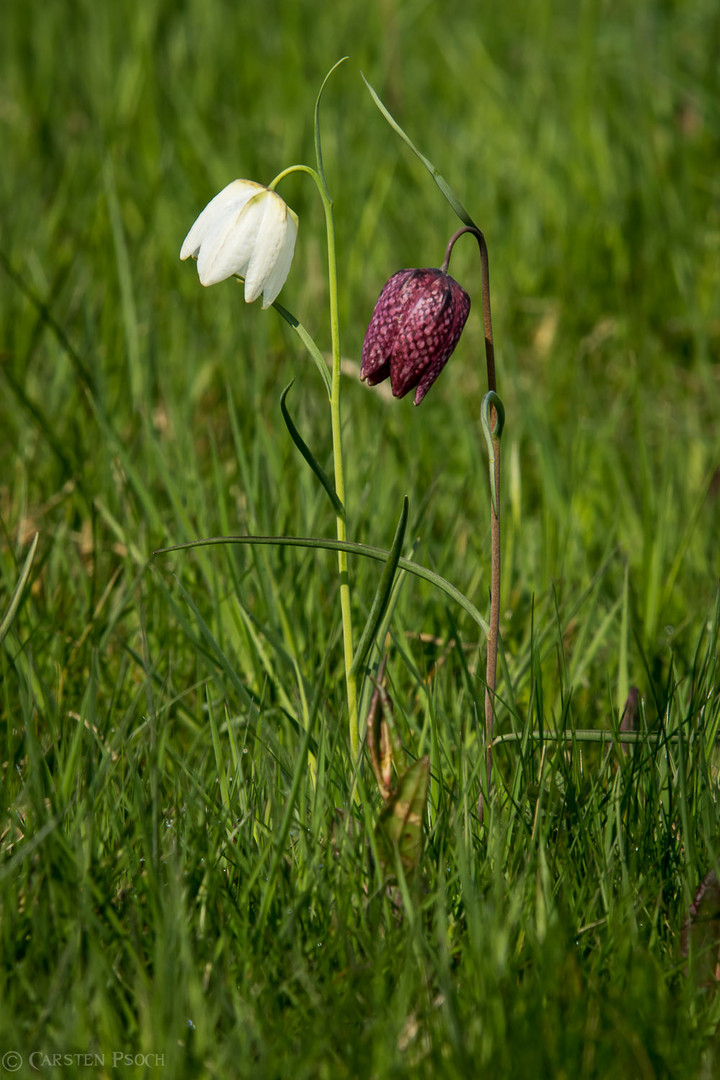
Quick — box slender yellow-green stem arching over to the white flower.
[269,165,359,761]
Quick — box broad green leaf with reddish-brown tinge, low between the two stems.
[376,757,430,874]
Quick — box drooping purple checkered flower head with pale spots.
[361,269,470,405]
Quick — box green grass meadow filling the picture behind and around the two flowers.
[0,0,720,1080]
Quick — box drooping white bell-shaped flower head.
[180,180,298,308]
